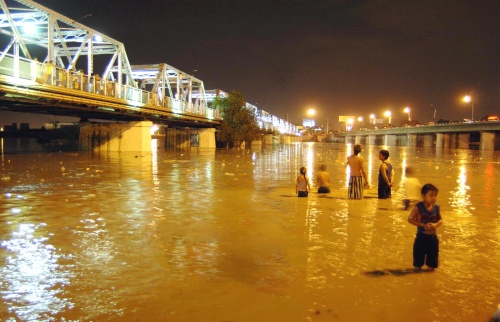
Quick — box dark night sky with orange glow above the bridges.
[0,0,500,126]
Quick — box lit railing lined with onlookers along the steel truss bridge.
[0,52,220,119]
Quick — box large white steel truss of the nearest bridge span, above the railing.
[0,0,137,87]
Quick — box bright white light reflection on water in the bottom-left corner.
[0,224,73,321]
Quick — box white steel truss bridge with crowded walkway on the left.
[0,0,297,134]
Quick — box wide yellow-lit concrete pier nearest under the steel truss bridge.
[80,121,153,152]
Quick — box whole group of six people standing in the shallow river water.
[295,144,442,271]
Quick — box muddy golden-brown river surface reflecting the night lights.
[0,143,500,322]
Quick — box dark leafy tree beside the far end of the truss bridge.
[213,91,260,148]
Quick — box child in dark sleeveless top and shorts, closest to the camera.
[408,183,443,271]
